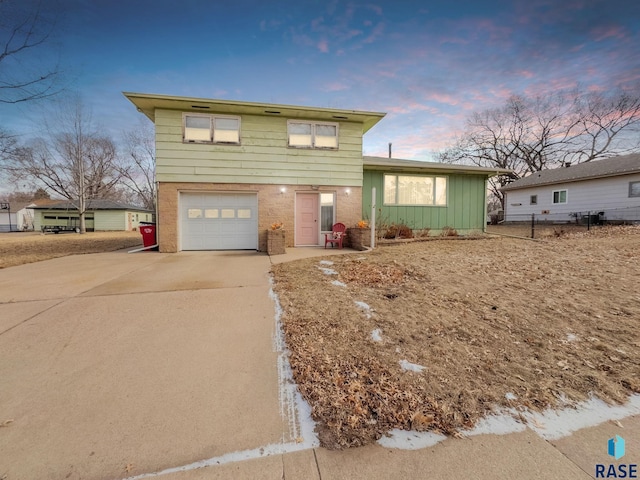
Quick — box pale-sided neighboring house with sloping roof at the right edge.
[502,154,640,222]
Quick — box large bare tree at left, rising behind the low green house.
[5,99,121,233]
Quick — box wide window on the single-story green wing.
[384,175,447,206]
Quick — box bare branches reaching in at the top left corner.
[0,0,61,103]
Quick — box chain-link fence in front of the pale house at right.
[487,206,640,239]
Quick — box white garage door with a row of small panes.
[180,193,258,250]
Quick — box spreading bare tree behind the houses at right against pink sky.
[440,86,640,207]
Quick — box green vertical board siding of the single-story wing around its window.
[362,170,487,233]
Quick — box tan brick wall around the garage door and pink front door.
[157,182,362,252]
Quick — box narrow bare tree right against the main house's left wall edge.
[120,119,156,210]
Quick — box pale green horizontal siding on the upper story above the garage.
[155,110,362,186]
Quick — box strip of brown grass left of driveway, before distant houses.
[0,232,142,268]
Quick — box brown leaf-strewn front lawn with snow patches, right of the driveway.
[273,227,640,448]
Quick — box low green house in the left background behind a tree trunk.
[29,200,153,231]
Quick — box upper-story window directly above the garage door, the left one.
[183,113,240,145]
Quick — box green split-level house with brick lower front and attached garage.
[124,93,508,252]
